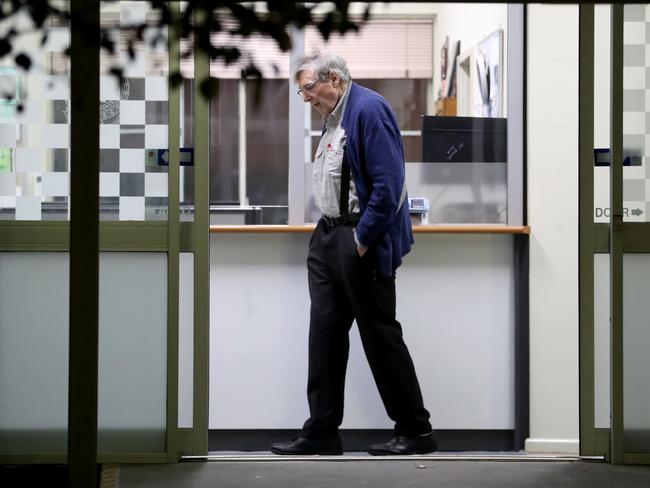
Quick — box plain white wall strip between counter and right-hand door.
[526,5,579,453]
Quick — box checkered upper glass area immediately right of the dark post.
[99,1,168,220]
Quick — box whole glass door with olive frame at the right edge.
[580,4,650,464]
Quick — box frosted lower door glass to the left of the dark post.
[0,252,69,453]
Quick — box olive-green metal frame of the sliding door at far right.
[579,0,650,464]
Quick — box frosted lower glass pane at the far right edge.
[623,254,650,453]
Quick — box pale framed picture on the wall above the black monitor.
[475,29,504,117]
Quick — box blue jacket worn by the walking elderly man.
[341,83,414,276]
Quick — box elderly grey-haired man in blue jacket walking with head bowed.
[271,53,437,455]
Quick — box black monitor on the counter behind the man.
[422,115,508,163]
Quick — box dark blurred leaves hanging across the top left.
[0,0,370,97]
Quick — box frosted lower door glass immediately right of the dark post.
[98,252,167,452]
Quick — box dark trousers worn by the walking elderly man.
[301,220,431,439]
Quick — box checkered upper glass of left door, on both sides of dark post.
[0,2,168,220]
